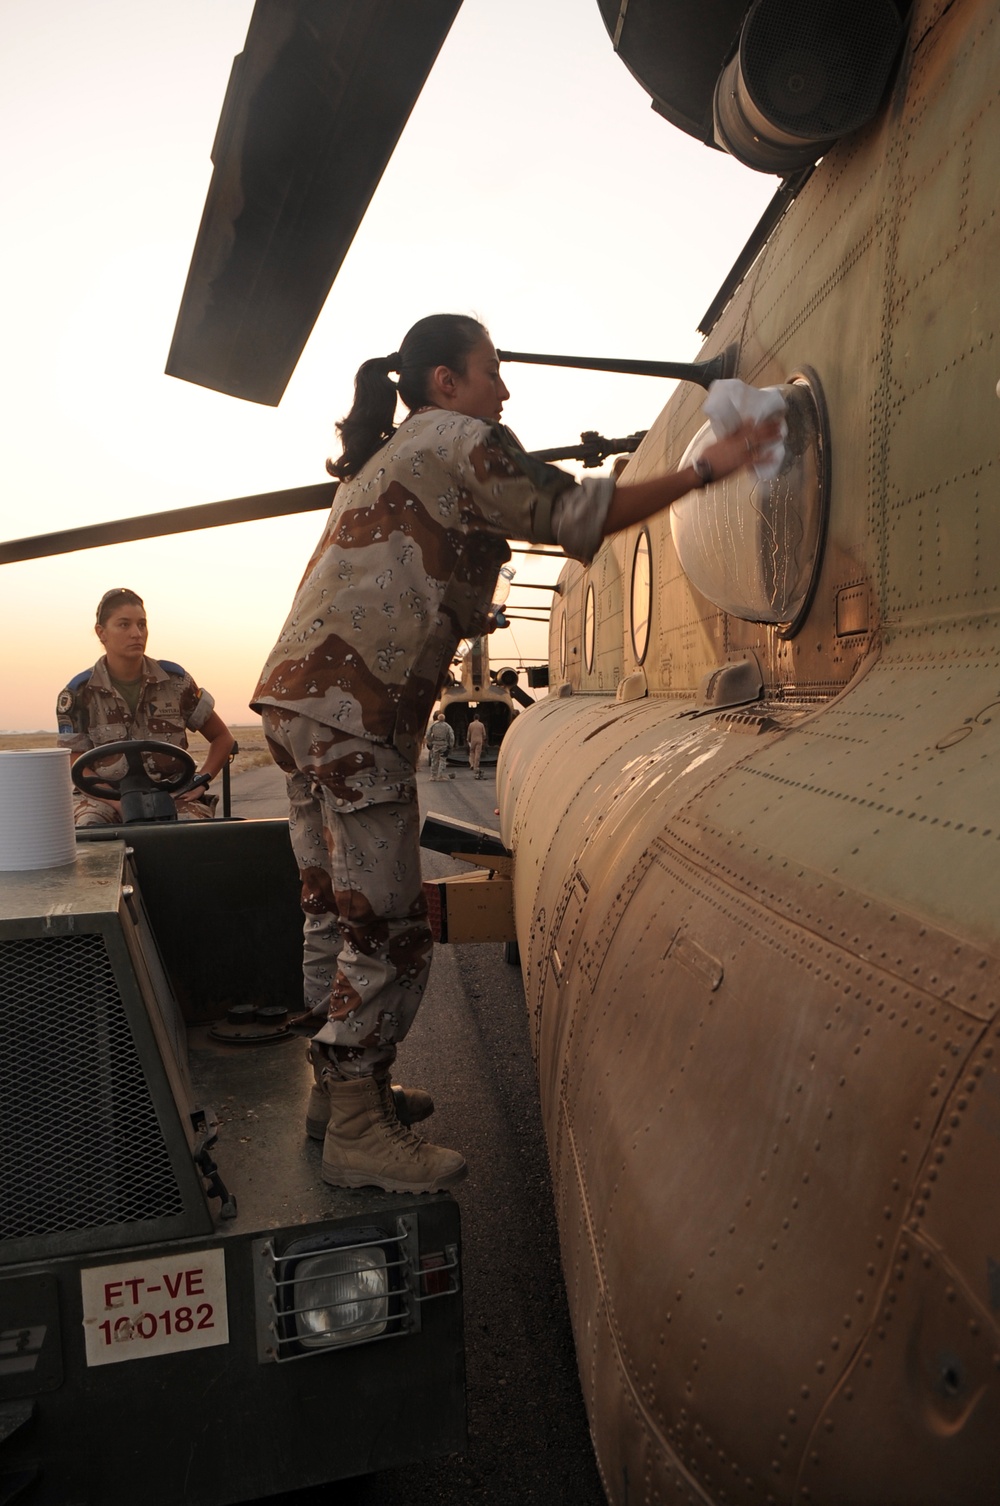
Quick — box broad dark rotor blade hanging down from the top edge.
[166,0,461,407]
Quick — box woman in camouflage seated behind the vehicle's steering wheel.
[56,589,233,827]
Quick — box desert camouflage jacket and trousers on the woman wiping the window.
[252,408,613,1077]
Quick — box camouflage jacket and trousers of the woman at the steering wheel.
[56,657,218,827]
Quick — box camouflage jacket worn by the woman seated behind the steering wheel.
[56,657,215,777]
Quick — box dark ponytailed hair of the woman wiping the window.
[327,313,486,480]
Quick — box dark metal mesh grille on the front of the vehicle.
[0,935,184,1239]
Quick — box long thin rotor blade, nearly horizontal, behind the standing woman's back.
[0,480,337,565]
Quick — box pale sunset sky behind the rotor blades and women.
[0,0,776,730]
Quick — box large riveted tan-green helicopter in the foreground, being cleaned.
[6,0,1000,1506]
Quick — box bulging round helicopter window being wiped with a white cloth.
[668,370,830,637]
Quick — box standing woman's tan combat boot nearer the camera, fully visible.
[322,1077,467,1193]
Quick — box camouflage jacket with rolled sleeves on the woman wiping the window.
[252,408,613,765]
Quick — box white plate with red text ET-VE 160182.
[80,1250,229,1364]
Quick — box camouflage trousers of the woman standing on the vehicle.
[262,706,432,1077]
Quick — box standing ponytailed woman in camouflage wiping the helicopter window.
[252,315,780,1191]
